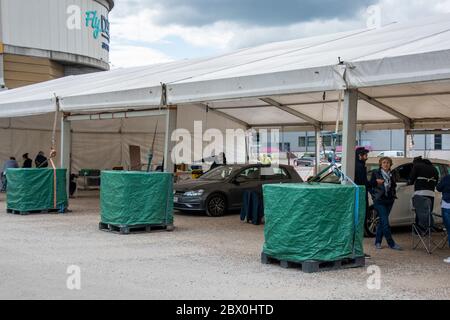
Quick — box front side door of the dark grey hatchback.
[230,166,261,208]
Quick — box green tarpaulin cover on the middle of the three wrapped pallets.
[100,171,173,226]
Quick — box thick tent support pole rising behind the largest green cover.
[342,89,358,179]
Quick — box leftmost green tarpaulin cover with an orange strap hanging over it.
[6,169,69,212]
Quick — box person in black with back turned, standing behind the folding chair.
[408,157,439,234]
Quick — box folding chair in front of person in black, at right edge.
[412,209,448,254]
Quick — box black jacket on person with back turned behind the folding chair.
[408,159,439,192]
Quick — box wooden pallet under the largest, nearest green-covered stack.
[261,252,366,273]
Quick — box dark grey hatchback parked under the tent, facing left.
[174,164,303,217]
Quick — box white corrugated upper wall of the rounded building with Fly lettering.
[0,0,109,62]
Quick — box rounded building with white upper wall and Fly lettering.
[0,0,114,89]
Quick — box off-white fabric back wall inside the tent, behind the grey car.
[0,106,245,172]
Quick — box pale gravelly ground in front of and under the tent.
[0,190,450,299]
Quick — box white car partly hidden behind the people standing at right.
[311,158,450,237]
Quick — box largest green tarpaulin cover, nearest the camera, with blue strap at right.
[263,183,366,262]
